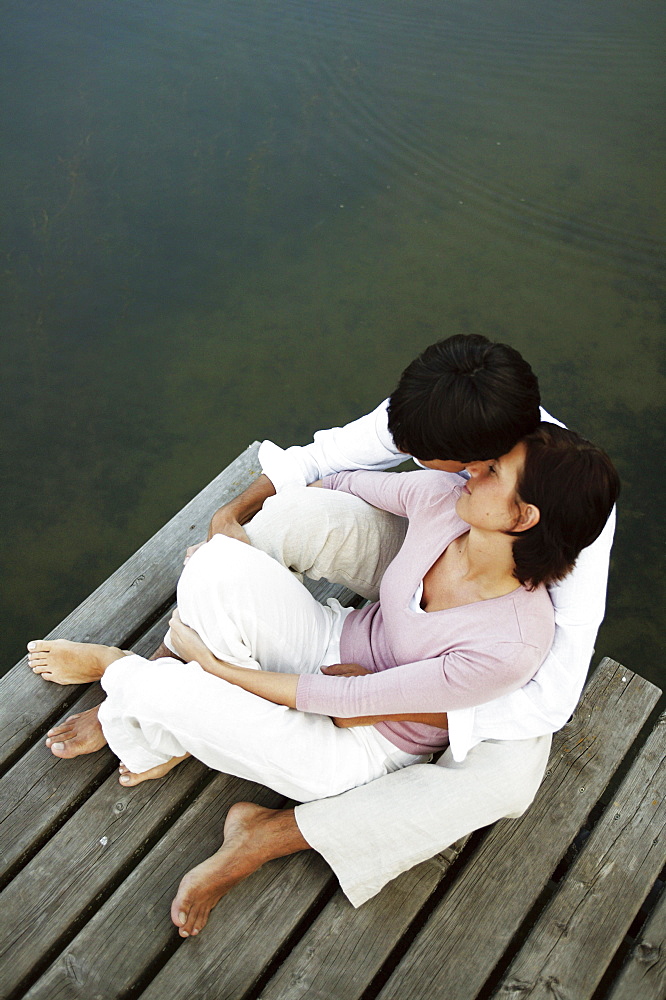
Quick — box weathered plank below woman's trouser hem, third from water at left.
[0,760,212,995]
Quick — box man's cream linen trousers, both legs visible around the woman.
[245,487,551,906]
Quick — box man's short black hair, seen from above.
[388,334,540,462]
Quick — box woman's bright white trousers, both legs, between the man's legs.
[99,535,424,801]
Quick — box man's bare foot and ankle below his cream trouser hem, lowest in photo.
[171,802,310,937]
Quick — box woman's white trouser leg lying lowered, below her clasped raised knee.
[99,656,416,801]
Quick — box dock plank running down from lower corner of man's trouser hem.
[254,838,468,1000]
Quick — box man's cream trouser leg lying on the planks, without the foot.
[296,736,551,906]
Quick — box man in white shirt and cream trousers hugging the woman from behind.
[37,336,614,936]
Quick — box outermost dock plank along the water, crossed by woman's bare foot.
[0,442,261,767]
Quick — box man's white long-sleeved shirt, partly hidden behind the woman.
[259,400,615,760]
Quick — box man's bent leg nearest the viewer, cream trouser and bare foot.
[171,736,550,937]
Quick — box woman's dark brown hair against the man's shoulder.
[508,423,620,589]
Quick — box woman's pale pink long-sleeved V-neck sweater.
[296,471,555,754]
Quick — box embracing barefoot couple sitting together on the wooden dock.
[28,335,619,937]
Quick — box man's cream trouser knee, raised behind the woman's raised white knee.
[244,486,407,601]
